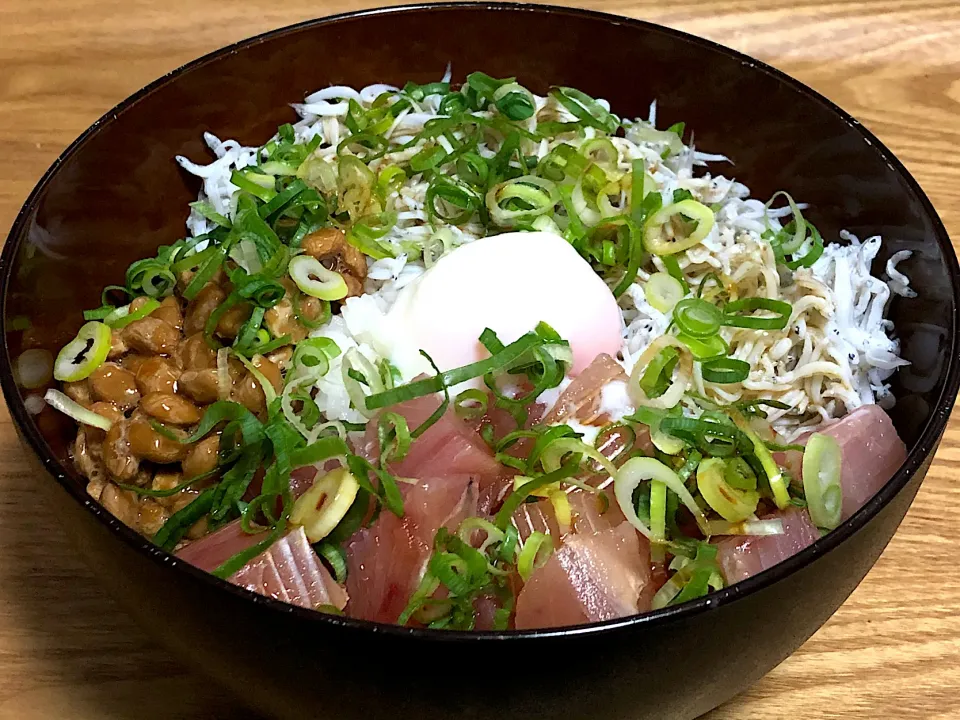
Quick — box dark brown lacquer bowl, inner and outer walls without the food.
[0,4,960,720]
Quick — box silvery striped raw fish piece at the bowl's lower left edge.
[230,527,347,610]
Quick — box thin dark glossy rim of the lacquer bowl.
[0,0,960,642]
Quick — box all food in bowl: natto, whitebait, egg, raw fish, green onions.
[41,72,915,630]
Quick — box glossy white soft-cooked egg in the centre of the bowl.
[387,232,623,375]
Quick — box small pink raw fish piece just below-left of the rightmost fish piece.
[717,508,820,584]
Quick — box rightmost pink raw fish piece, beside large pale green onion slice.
[785,405,907,520]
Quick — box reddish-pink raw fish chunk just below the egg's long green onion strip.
[357,395,502,485]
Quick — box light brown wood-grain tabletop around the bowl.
[0,0,960,720]
